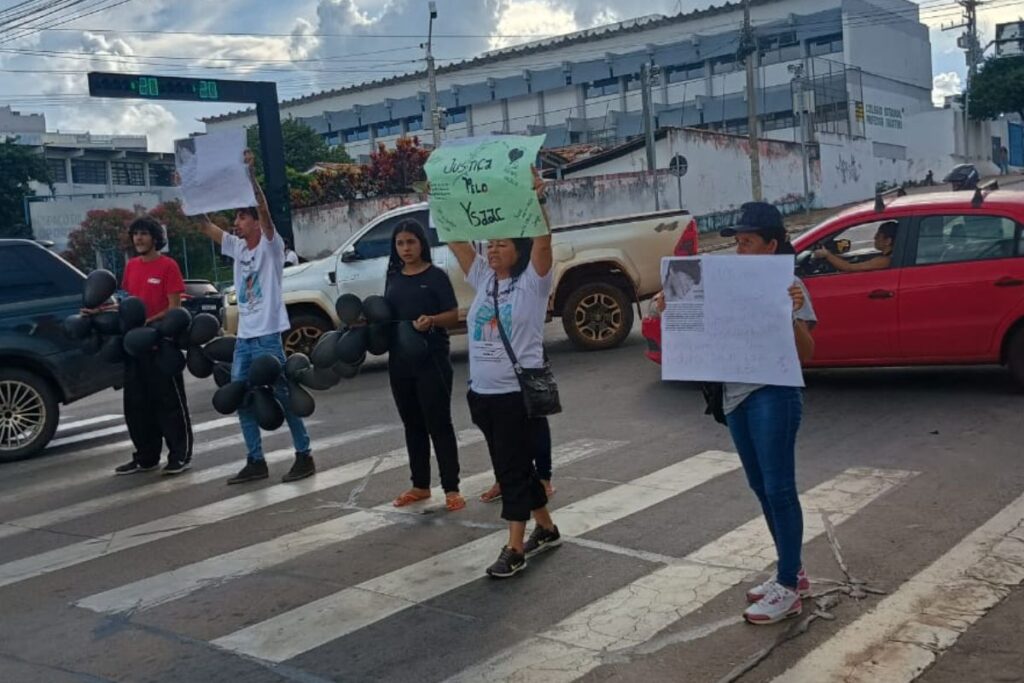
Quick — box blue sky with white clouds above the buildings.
[0,0,1024,151]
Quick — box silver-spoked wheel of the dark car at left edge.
[0,369,60,462]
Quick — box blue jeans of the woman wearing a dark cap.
[726,386,804,589]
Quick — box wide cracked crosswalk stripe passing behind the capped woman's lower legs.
[449,469,915,683]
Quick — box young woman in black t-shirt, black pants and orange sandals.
[384,220,466,511]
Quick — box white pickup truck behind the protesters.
[225,203,693,353]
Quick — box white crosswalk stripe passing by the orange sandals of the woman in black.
[76,438,626,613]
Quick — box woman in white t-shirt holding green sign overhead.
[449,178,561,579]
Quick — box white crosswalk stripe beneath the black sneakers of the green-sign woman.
[213,452,739,661]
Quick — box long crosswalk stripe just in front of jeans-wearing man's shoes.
[0,425,408,588]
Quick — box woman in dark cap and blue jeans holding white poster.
[658,202,817,624]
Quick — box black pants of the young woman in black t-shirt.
[390,354,459,493]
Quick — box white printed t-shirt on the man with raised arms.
[220,234,291,339]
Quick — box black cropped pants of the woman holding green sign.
[468,391,548,522]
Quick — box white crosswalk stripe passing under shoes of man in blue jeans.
[0,421,394,539]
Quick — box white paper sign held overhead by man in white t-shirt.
[174,129,256,216]
